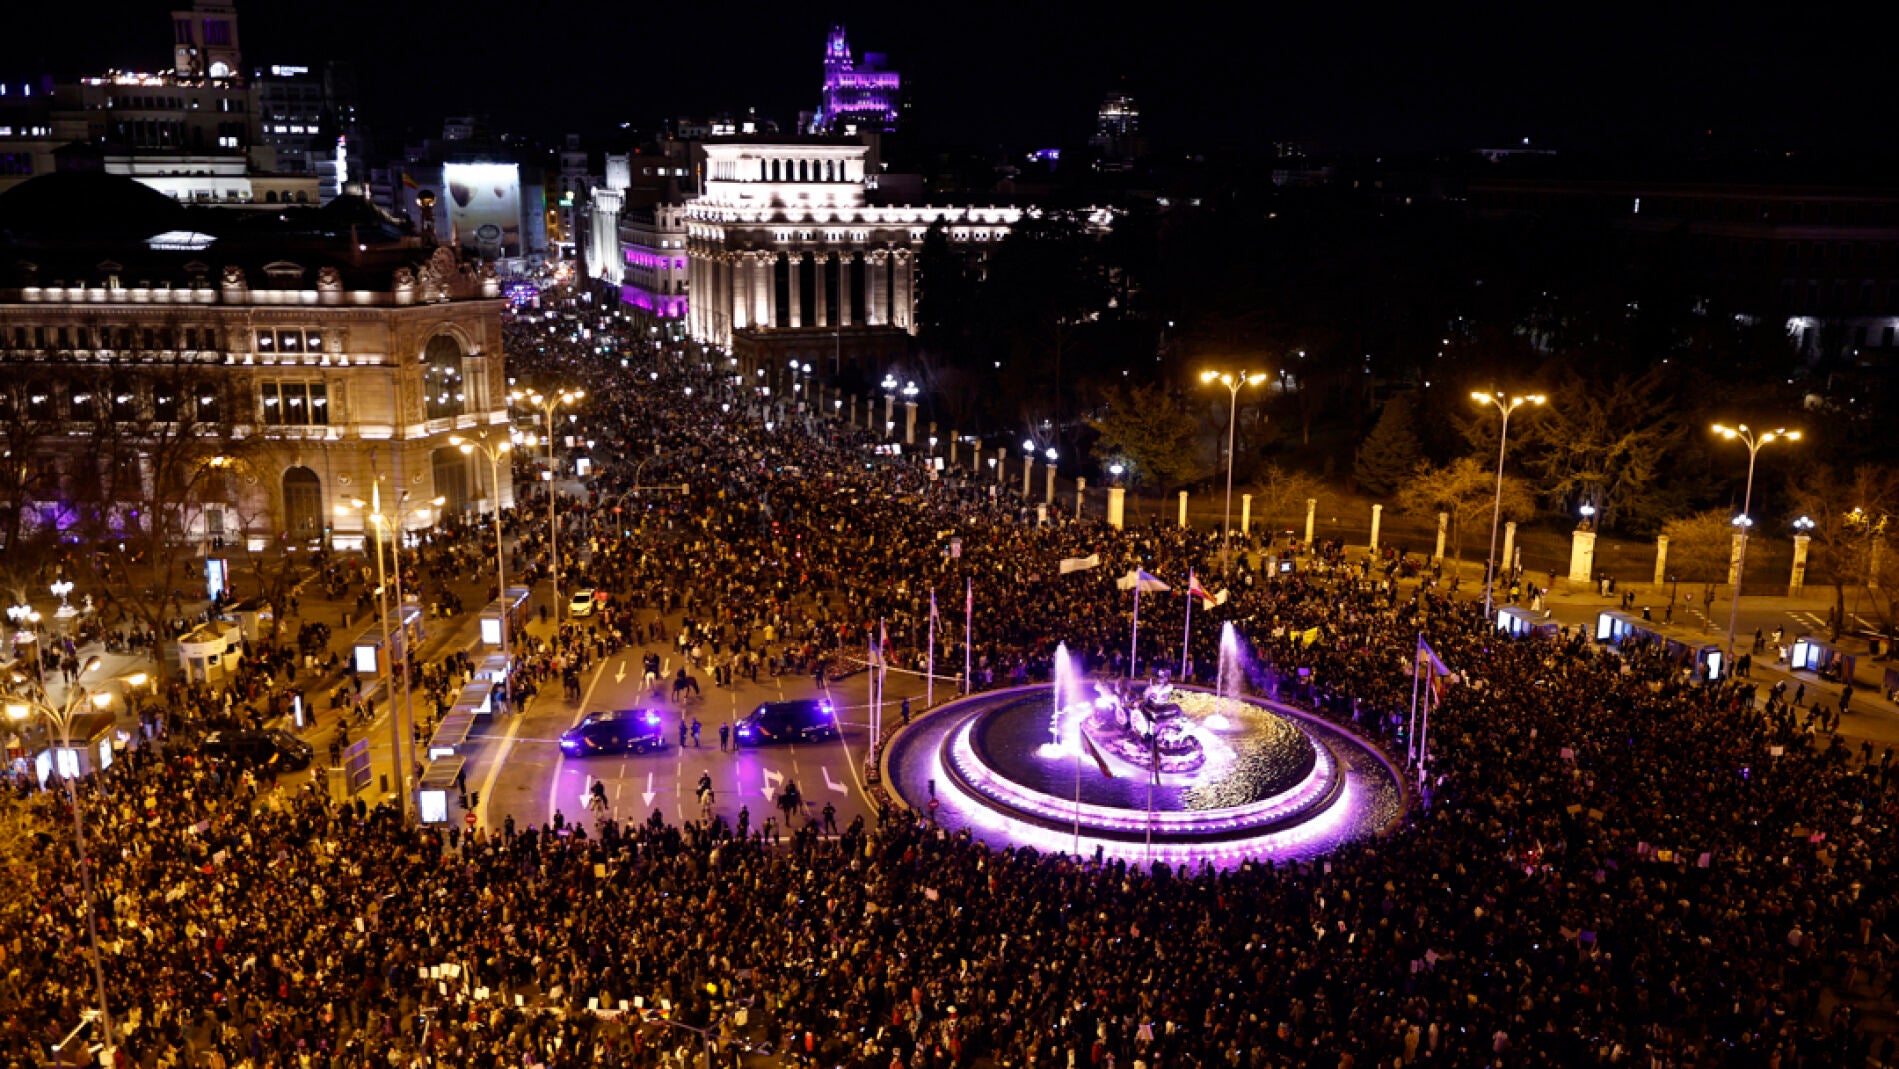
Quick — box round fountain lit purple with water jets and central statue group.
[887,623,1401,864]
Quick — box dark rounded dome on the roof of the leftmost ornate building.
[0,171,182,245]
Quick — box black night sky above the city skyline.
[0,0,1893,156]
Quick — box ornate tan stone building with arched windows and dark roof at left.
[0,175,511,547]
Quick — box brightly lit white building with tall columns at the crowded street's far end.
[686,139,1022,361]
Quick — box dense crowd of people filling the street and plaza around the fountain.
[0,296,1899,1069]
